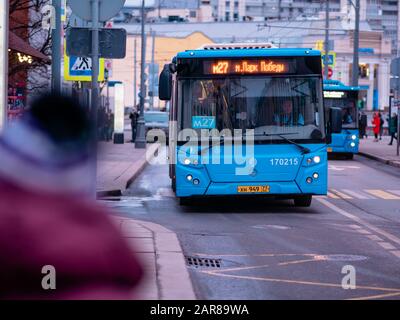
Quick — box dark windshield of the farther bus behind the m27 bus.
[325,95,358,129]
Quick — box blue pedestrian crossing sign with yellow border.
[64,54,104,82]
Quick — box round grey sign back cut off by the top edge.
[68,0,126,22]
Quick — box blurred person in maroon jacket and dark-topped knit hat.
[0,95,142,300]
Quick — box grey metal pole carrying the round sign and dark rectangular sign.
[90,0,100,194]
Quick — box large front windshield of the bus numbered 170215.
[179,76,325,140]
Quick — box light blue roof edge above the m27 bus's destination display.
[176,48,321,59]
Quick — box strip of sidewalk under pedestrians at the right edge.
[359,136,400,168]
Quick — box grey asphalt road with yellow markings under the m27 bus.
[102,157,400,299]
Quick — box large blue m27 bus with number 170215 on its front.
[159,44,341,207]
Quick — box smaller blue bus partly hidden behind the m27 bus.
[324,80,360,159]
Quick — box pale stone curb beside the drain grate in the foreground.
[122,218,196,300]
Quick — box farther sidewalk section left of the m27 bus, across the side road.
[97,142,157,197]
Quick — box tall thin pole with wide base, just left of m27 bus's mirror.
[135,0,146,149]
